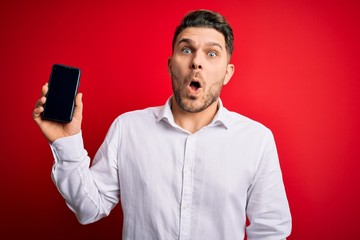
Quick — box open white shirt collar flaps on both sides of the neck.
[156,97,230,129]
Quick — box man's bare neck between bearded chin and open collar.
[171,98,219,133]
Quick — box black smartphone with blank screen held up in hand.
[42,64,81,123]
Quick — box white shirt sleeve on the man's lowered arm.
[246,131,291,240]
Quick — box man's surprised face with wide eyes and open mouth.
[168,27,234,112]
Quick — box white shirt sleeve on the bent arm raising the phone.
[51,119,120,224]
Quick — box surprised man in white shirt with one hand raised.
[33,10,291,240]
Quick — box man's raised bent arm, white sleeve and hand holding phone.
[33,84,119,224]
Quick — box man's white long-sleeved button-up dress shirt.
[51,99,291,240]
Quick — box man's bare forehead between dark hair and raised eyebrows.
[176,27,225,48]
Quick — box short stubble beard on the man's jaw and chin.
[170,72,223,113]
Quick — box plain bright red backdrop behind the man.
[0,0,360,240]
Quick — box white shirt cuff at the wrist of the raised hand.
[50,132,87,162]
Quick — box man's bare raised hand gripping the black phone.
[32,83,83,143]
